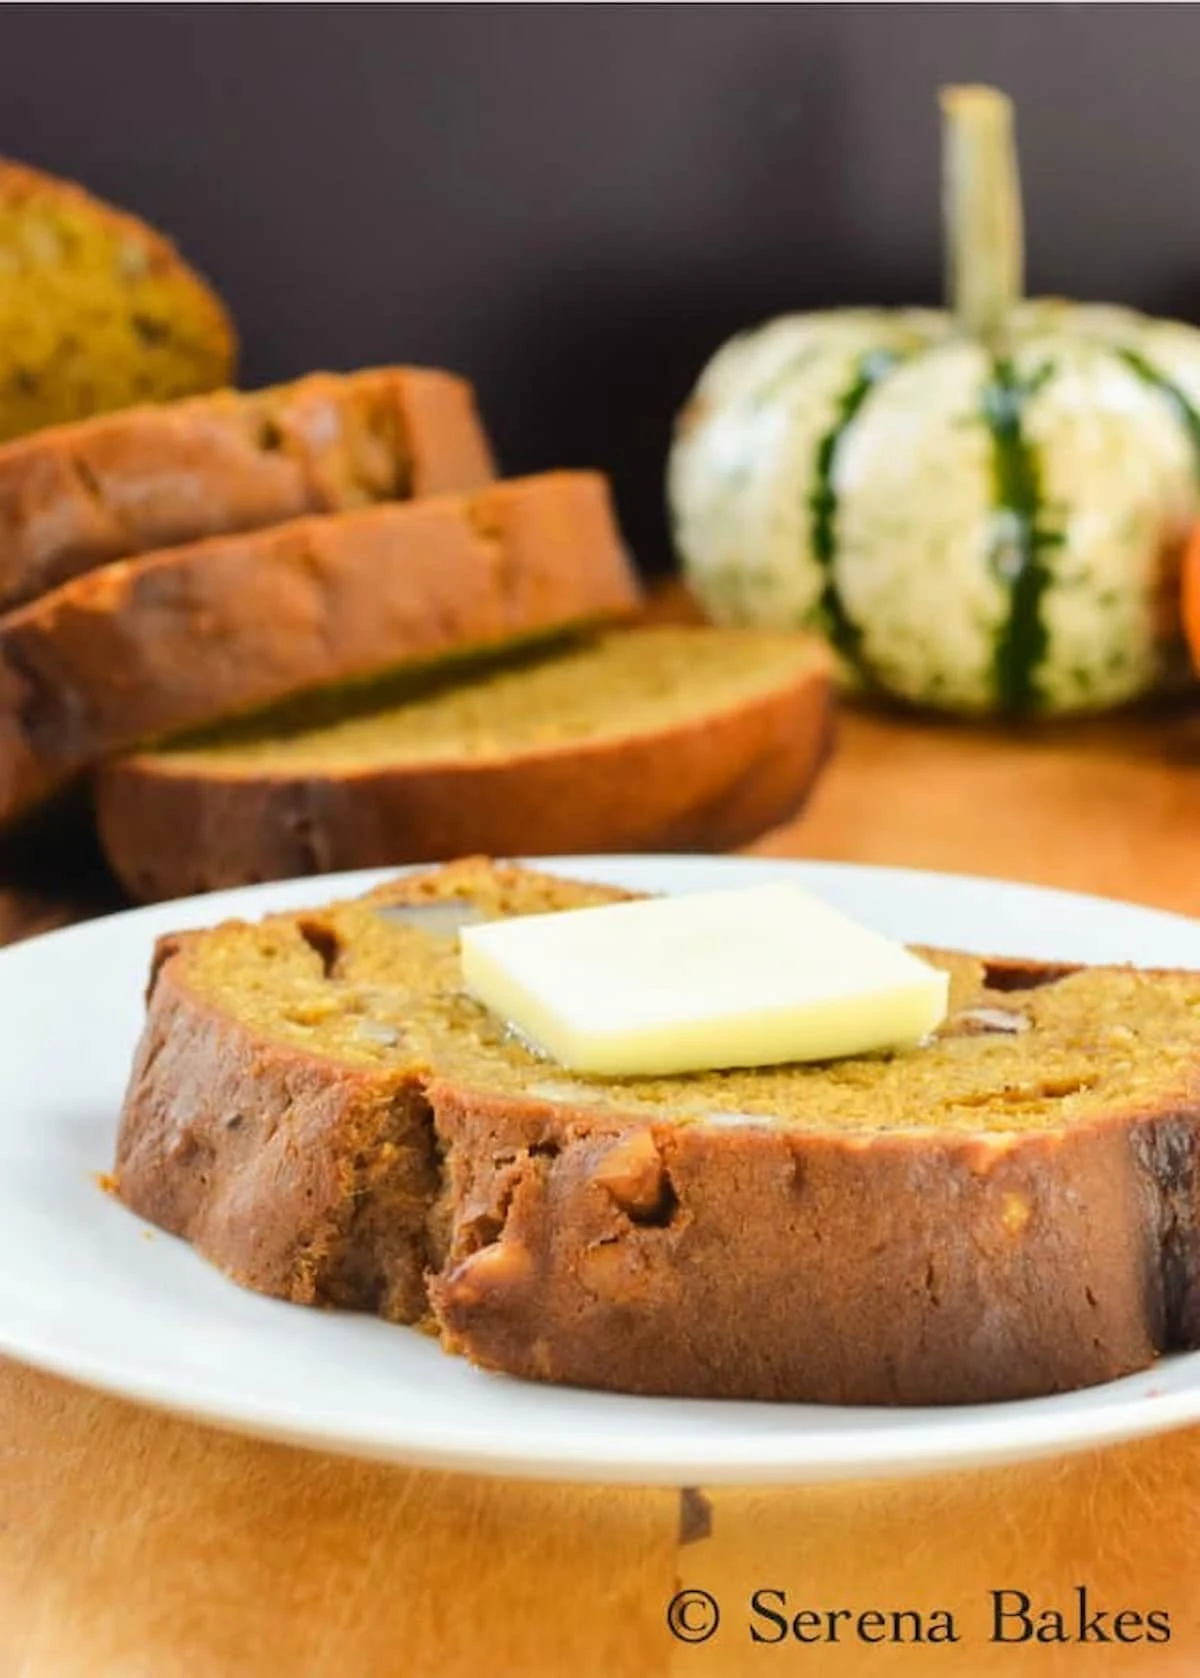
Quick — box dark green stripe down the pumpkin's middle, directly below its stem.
[982,356,1062,717]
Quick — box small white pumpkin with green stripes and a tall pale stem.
[668,87,1200,715]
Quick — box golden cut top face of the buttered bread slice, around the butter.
[155,868,1200,1134]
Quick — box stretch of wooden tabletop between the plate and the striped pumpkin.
[752,710,1200,915]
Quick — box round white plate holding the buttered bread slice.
[0,857,1200,1485]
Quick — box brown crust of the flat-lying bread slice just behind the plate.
[96,629,832,899]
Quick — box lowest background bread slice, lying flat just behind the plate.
[96,628,831,899]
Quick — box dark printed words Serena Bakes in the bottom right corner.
[747,1586,1171,1644]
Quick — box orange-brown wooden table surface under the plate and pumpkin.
[0,701,1200,1678]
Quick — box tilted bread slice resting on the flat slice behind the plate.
[0,472,639,821]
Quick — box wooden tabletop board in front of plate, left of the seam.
[0,1364,678,1678]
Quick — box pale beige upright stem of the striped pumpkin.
[940,87,1025,344]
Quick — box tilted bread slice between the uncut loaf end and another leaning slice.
[0,364,493,609]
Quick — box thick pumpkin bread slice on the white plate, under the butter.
[114,861,1200,1404]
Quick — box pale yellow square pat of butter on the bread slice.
[458,883,950,1077]
